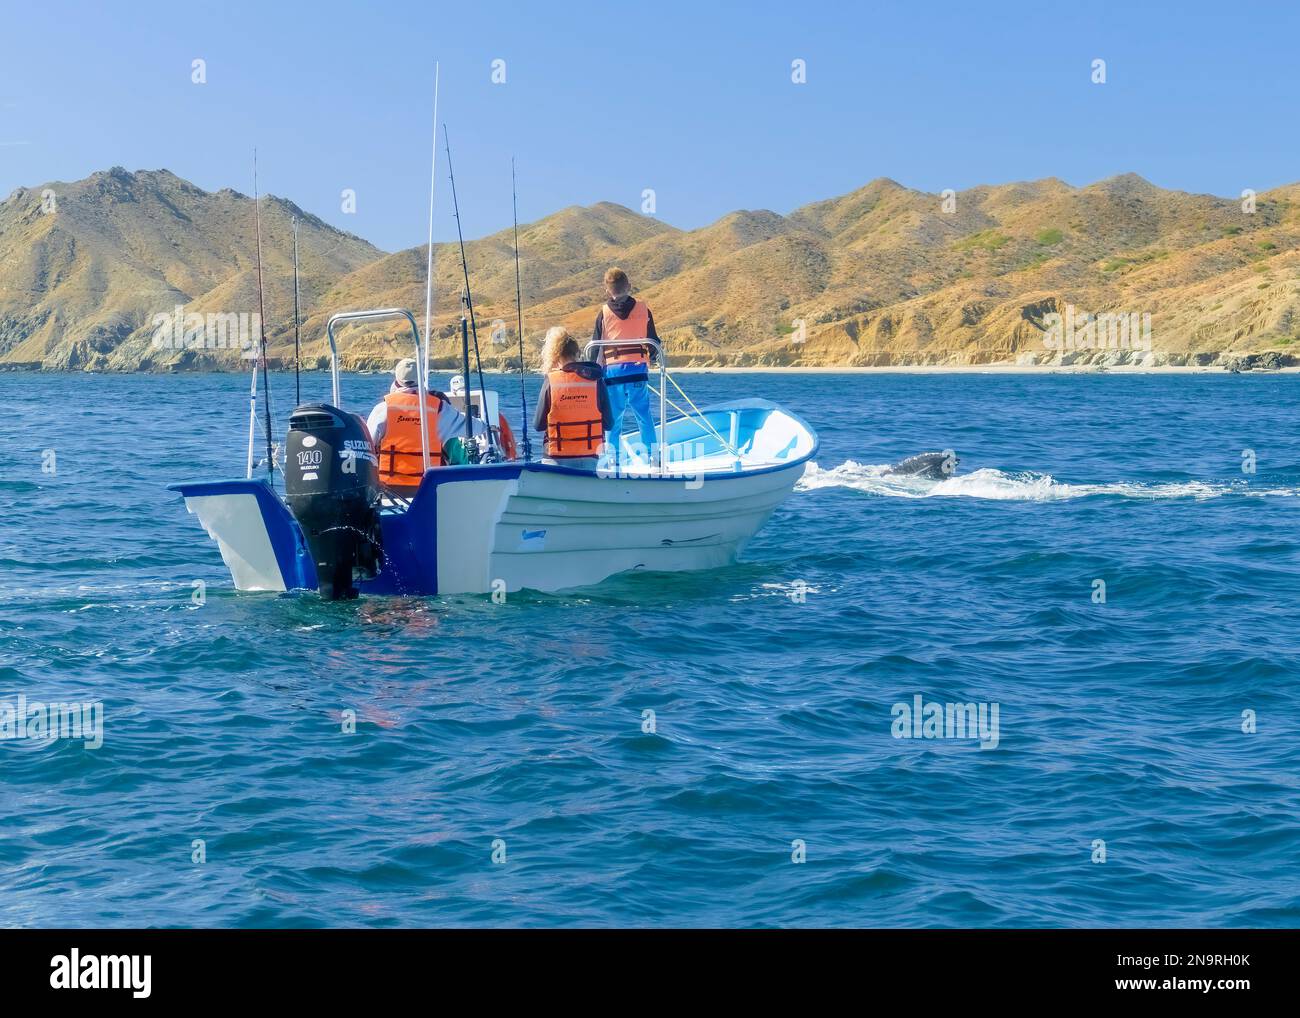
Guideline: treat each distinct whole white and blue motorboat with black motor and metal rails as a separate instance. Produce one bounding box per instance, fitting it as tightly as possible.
[170,308,818,599]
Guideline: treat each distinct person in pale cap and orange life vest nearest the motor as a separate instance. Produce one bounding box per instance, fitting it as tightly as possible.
[367,358,484,489]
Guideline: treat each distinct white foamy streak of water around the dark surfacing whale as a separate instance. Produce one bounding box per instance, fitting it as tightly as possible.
[794,459,1300,502]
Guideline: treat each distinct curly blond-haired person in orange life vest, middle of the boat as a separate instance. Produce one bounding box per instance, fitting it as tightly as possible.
[533,325,614,471]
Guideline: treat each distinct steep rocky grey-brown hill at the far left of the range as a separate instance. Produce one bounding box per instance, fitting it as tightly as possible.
[0,168,381,369]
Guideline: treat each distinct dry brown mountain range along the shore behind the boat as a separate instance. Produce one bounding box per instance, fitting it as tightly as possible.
[0,168,1300,371]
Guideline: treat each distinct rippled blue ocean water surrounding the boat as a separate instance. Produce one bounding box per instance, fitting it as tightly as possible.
[0,374,1300,927]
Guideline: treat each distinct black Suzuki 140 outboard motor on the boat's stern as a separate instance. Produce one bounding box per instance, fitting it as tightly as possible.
[285,403,384,601]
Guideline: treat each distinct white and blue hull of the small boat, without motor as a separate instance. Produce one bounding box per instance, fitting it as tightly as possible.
[173,400,816,594]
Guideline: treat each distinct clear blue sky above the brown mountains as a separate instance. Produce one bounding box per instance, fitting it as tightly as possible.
[0,0,1300,250]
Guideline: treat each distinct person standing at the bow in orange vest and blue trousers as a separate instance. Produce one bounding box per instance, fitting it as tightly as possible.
[592,268,659,459]
